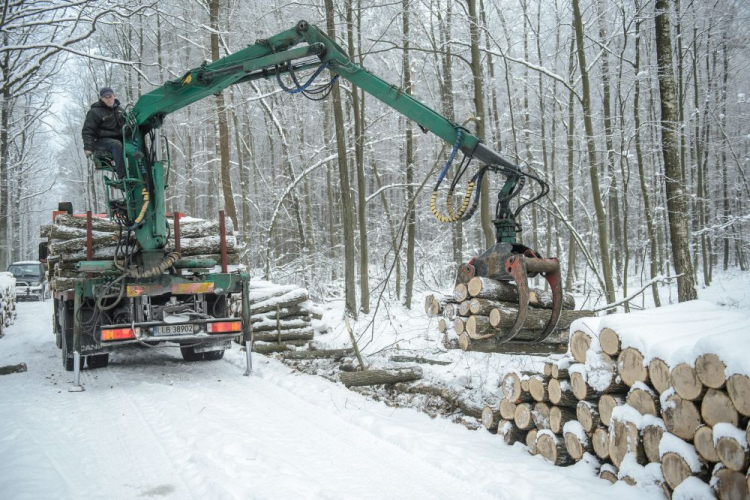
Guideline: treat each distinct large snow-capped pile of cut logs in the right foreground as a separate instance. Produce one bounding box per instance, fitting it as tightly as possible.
[498,301,750,499]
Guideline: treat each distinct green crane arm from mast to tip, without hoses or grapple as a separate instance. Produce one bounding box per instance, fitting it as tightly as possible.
[124,21,528,256]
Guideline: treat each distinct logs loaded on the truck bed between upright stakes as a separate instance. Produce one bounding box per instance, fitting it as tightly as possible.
[39,214,240,290]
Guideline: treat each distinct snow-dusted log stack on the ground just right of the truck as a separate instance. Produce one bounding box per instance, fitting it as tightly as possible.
[242,280,322,353]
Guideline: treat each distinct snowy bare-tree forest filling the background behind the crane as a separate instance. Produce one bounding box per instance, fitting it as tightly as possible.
[0,0,750,311]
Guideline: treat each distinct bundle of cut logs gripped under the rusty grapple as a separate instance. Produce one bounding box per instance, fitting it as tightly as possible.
[425,276,594,354]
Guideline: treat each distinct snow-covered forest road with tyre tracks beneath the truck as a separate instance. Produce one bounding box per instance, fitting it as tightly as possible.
[0,301,658,500]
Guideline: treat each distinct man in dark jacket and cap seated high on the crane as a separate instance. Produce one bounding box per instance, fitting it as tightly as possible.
[81,87,125,179]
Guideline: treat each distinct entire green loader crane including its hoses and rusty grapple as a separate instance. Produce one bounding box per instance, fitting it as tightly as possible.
[107,21,562,340]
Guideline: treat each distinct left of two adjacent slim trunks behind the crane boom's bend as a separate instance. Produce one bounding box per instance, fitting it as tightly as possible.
[325,0,358,318]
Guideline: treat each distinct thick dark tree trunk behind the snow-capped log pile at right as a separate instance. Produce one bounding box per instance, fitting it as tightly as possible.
[655,0,698,302]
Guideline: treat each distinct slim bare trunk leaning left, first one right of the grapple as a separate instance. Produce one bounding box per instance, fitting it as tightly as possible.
[573,0,615,304]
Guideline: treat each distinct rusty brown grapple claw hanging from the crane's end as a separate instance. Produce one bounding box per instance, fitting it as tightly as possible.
[458,243,563,342]
